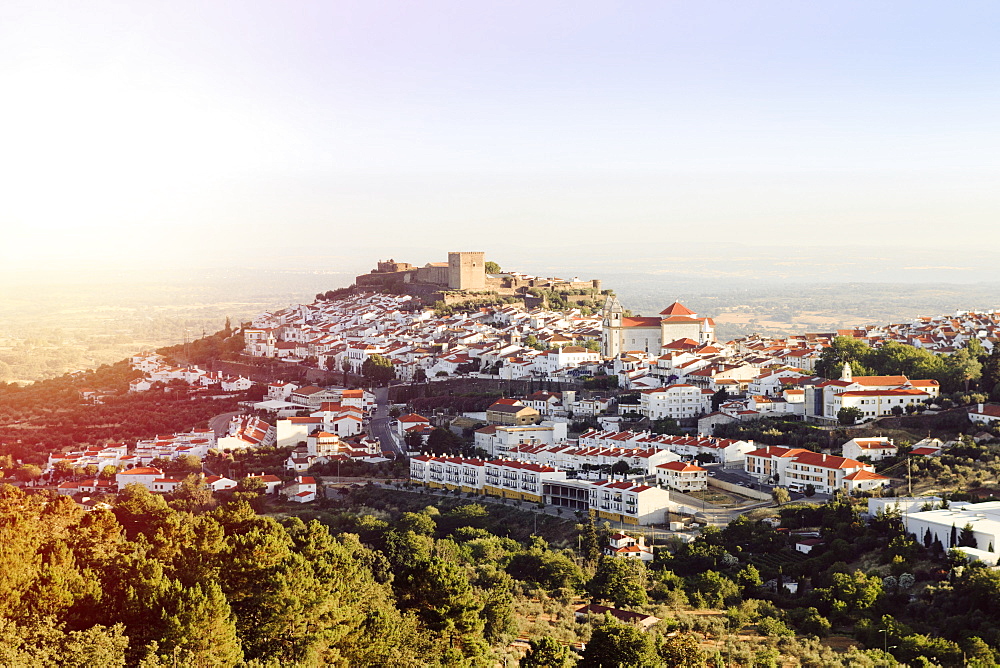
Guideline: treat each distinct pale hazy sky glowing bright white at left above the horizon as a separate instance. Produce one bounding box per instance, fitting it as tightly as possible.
[0,0,1000,276]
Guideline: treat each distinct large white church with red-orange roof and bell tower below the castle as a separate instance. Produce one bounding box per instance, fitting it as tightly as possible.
[601,295,715,357]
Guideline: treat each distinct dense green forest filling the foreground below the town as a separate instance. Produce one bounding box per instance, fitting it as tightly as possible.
[0,468,1000,668]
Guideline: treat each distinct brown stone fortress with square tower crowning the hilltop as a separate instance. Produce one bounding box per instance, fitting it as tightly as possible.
[354,251,601,304]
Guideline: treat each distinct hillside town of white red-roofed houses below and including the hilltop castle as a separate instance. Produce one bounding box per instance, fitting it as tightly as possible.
[8,253,1000,665]
